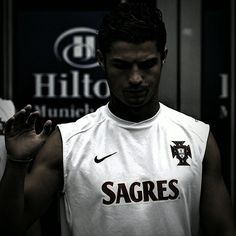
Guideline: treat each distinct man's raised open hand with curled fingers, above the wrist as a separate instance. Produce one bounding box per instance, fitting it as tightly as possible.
[5,105,52,160]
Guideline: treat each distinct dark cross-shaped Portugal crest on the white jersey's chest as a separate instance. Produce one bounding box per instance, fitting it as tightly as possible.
[170,141,192,166]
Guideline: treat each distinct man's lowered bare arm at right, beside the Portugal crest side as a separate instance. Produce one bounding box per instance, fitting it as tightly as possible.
[200,134,236,236]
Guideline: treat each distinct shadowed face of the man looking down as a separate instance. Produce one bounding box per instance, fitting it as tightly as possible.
[103,41,162,107]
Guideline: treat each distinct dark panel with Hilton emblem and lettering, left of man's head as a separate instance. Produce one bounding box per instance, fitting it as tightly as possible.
[13,10,109,128]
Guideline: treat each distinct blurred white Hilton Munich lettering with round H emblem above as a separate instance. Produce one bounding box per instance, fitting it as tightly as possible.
[32,27,110,119]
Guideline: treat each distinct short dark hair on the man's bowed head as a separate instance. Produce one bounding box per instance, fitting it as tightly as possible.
[98,1,166,55]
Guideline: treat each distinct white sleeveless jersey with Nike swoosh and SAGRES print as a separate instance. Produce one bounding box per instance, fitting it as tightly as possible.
[59,104,209,236]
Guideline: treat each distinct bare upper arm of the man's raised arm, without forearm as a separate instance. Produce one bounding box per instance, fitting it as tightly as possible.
[24,130,63,230]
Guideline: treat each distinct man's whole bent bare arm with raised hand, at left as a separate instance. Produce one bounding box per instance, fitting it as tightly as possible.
[0,106,62,235]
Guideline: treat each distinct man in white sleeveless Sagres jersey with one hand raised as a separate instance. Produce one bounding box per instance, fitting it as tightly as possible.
[0,3,235,236]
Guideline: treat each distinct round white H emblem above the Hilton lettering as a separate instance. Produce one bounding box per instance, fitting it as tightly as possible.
[54,27,98,69]
